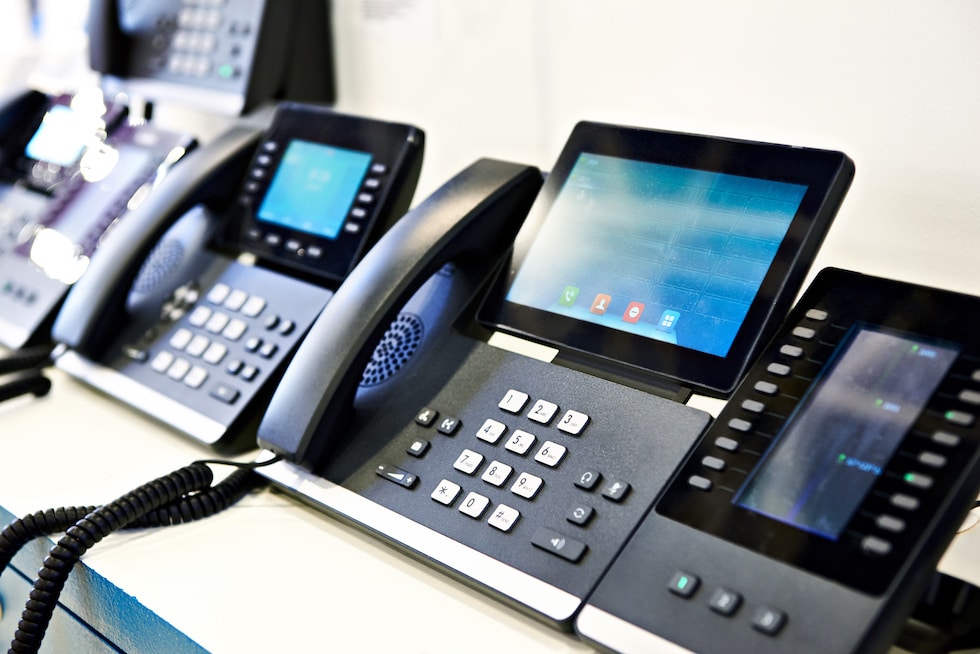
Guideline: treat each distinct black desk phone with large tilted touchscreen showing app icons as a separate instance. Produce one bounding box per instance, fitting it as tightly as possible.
[258,123,853,629]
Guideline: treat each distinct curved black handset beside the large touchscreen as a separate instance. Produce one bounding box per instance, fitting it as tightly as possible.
[258,159,542,465]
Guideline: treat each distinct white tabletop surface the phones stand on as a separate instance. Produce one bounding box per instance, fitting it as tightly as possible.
[0,371,980,654]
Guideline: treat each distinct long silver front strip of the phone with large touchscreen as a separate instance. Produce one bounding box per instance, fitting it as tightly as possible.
[257,456,582,623]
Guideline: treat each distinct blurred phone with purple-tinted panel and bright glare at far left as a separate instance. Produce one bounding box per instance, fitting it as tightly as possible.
[0,89,194,348]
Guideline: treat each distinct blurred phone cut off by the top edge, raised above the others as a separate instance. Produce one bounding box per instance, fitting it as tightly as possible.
[89,0,335,115]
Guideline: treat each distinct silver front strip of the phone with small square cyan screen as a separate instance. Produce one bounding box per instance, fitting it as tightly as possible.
[55,350,227,445]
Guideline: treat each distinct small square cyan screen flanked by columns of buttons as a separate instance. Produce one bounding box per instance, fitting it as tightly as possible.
[256,140,371,239]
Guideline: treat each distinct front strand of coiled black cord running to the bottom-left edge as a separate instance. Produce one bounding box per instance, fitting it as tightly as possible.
[8,464,214,654]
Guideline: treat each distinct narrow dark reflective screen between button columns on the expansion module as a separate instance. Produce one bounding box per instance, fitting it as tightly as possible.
[733,326,959,540]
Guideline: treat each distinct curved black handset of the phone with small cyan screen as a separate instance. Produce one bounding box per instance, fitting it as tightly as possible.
[51,123,262,357]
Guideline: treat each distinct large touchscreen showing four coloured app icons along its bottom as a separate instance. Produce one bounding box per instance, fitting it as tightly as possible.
[506,152,807,357]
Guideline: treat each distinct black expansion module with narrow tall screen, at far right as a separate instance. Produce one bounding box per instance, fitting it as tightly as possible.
[577,269,980,654]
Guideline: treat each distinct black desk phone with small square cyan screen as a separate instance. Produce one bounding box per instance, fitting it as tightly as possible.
[52,103,424,447]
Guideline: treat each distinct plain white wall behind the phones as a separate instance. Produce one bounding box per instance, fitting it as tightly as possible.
[0,0,980,294]
